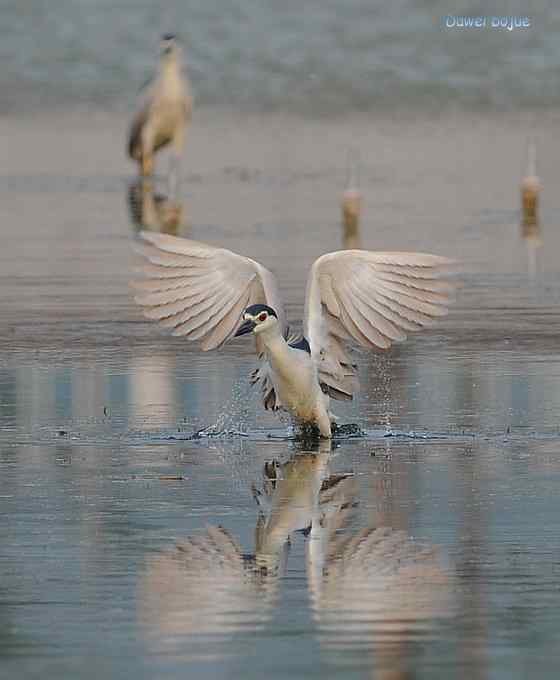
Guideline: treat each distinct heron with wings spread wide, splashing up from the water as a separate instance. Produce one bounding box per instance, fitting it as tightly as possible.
[135,232,453,437]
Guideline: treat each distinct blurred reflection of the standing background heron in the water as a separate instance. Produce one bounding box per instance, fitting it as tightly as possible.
[127,179,191,237]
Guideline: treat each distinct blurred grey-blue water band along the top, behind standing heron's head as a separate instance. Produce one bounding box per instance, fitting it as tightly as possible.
[0,0,560,118]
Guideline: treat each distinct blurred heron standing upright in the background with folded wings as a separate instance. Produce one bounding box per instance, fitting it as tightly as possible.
[128,35,192,176]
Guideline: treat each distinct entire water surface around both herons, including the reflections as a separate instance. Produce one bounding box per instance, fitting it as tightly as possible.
[0,5,560,680]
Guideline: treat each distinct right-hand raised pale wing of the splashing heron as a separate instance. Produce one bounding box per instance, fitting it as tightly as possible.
[304,250,454,399]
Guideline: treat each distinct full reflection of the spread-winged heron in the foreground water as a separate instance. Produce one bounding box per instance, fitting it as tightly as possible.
[139,442,449,651]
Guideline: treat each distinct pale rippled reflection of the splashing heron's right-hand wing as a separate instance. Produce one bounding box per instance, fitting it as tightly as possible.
[311,527,447,646]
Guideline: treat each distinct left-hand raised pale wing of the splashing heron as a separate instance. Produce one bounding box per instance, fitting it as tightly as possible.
[133,231,286,351]
